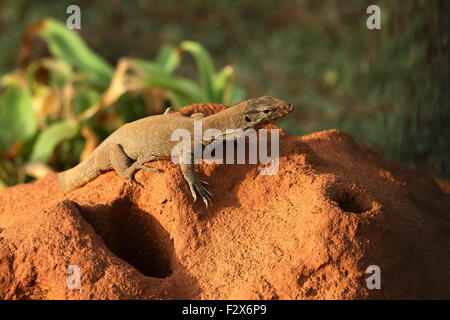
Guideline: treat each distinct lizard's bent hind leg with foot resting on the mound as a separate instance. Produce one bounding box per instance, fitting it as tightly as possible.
[96,144,160,186]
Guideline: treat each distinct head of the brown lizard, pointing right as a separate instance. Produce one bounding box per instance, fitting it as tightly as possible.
[237,96,294,129]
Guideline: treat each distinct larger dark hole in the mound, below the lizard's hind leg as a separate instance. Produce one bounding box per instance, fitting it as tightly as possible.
[81,199,174,278]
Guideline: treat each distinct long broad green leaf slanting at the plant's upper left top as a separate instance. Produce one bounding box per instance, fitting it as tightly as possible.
[37,18,114,86]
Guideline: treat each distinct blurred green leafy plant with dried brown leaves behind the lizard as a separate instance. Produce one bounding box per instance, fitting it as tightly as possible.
[0,19,244,188]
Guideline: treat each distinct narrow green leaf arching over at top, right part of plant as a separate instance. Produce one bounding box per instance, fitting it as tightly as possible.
[180,41,215,102]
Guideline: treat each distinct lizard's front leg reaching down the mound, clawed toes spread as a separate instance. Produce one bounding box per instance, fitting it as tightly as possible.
[180,152,212,208]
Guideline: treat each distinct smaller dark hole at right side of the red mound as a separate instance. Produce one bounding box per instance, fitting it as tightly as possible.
[330,185,373,213]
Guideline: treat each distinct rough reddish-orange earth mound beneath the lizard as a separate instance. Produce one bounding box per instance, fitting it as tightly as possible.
[0,105,450,299]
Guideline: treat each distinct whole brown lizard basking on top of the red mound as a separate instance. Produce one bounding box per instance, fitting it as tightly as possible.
[58,96,294,207]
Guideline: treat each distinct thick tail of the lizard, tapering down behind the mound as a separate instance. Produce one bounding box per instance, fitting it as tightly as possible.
[58,156,102,192]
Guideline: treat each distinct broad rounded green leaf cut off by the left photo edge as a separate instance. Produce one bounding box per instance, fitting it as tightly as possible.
[0,85,37,150]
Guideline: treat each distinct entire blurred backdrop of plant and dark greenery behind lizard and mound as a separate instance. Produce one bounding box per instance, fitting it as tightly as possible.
[0,0,450,188]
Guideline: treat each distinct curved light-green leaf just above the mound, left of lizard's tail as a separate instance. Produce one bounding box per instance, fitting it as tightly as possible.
[30,120,78,162]
